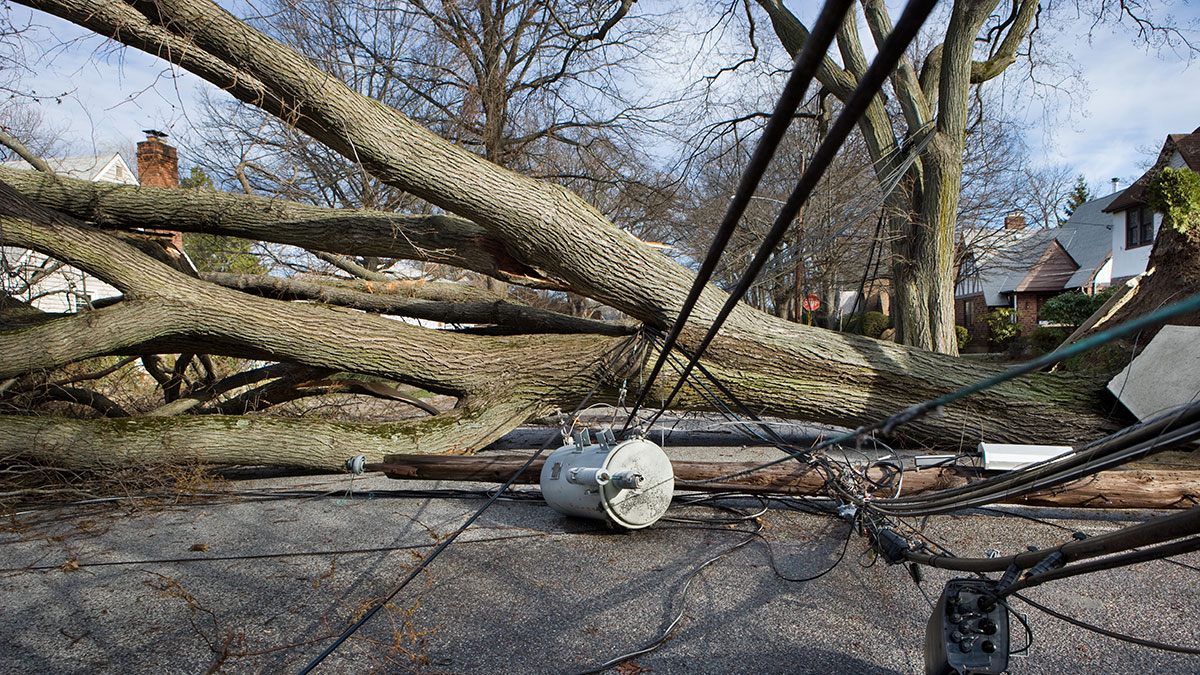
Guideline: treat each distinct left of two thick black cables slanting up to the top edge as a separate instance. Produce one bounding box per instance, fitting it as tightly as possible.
[622,0,854,432]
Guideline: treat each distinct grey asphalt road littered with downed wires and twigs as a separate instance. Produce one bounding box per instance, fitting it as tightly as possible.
[0,427,1200,675]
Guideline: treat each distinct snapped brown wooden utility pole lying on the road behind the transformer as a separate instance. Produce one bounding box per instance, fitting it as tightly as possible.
[365,455,1200,509]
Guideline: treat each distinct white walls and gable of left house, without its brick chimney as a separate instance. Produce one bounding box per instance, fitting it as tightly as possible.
[0,153,138,312]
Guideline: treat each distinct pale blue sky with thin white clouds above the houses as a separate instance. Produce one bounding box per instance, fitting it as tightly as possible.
[8,2,1200,195]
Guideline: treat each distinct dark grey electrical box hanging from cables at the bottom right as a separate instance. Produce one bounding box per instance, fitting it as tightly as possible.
[925,571,1008,675]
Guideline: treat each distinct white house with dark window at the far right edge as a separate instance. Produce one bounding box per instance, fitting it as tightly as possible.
[1104,127,1200,281]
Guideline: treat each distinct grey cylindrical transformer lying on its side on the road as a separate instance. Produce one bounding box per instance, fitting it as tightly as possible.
[541,431,674,530]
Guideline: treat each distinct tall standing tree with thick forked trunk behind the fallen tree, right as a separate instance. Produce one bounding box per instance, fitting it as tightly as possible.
[758,0,1190,353]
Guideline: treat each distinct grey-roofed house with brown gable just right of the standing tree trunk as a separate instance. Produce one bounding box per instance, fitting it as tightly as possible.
[954,192,1118,345]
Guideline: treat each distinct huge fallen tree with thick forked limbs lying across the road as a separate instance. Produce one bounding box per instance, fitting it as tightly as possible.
[0,0,1111,466]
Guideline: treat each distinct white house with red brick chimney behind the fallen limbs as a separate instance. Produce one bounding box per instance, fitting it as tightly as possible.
[0,132,182,313]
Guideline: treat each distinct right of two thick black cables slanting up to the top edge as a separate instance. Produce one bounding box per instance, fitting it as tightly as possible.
[652,0,937,424]
